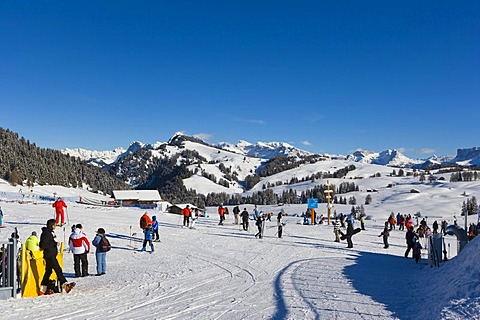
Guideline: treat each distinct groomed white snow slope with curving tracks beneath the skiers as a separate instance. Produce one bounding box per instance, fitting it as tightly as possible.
[0,179,480,320]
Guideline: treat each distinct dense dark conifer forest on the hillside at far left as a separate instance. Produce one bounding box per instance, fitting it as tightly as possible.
[0,128,130,194]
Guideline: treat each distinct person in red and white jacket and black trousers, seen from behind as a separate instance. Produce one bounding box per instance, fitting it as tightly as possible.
[68,223,90,278]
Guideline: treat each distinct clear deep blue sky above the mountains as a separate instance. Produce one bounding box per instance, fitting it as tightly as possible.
[0,0,480,158]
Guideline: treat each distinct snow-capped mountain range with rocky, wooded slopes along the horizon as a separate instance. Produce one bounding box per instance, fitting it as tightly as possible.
[62,132,480,194]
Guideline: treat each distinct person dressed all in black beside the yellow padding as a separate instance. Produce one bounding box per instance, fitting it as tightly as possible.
[39,219,75,295]
